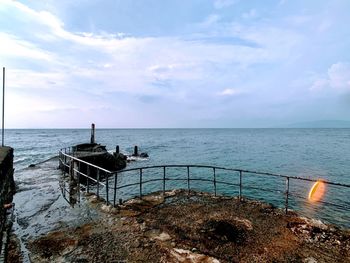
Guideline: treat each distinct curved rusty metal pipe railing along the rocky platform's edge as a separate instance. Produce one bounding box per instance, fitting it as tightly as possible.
[59,149,350,227]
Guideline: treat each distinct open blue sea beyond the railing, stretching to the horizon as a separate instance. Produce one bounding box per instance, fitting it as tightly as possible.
[5,129,350,232]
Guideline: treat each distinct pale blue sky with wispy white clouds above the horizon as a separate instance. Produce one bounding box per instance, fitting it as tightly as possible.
[0,0,350,128]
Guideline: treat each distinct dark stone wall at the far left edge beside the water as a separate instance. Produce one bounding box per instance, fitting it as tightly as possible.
[0,147,15,262]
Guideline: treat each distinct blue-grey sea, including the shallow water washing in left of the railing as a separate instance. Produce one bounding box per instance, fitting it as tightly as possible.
[5,128,350,260]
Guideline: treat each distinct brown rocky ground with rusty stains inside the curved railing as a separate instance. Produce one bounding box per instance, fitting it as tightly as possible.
[10,190,350,263]
